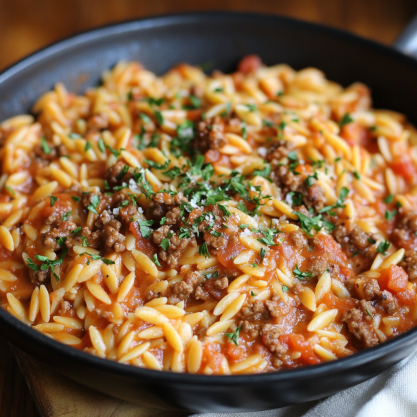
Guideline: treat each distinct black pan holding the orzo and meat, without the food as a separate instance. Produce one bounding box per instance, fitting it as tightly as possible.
[0,13,417,412]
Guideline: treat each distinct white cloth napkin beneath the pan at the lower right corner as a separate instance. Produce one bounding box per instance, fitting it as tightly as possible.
[192,353,417,417]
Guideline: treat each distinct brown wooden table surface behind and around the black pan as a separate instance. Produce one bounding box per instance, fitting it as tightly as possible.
[0,0,417,417]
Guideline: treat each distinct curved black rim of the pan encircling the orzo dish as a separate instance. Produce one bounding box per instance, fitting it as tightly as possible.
[0,11,417,386]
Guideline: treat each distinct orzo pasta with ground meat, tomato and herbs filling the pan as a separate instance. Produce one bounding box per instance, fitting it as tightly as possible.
[0,56,417,374]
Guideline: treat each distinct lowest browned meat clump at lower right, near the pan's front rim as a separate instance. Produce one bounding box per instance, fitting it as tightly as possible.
[342,300,379,347]
